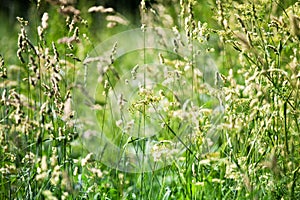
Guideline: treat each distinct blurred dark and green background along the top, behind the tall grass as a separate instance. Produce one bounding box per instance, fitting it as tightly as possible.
[0,0,297,64]
